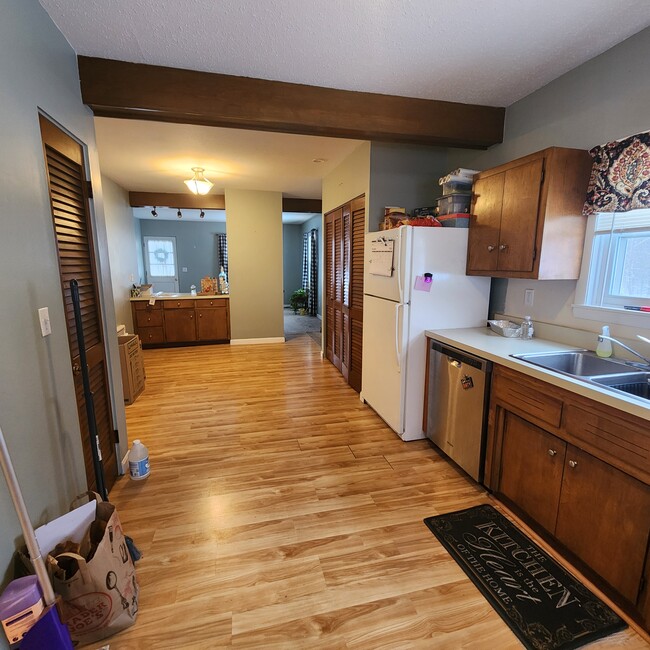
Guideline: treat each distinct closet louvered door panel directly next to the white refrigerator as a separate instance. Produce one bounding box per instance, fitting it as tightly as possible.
[348,196,366,392]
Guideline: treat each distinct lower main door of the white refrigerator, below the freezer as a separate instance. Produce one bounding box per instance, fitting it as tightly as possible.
[361,296,409,435]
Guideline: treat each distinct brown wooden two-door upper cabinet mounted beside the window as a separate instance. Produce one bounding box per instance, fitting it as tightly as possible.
[467,147,591,280]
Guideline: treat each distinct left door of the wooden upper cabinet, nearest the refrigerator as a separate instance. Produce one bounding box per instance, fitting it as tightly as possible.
[467,173,505,271]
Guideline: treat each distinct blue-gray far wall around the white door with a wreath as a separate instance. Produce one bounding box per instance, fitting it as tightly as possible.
[136,219,225,293]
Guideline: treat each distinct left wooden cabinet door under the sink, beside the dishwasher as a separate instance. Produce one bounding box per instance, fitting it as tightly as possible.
[498,411,567,533]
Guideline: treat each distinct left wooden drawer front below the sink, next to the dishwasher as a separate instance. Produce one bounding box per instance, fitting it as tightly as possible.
[492,368,562,427]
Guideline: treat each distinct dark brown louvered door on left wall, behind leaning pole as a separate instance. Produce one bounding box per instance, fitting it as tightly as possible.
[40,116,118,490]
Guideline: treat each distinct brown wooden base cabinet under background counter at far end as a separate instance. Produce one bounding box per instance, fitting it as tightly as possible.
[131,298,230,347]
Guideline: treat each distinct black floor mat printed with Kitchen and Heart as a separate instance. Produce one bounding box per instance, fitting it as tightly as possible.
[424,505,627,650]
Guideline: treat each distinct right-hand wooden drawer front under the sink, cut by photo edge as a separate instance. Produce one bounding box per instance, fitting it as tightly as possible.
[565,404,650,484]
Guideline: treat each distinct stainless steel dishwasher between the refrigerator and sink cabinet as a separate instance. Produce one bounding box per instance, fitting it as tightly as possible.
[426,341,492,483]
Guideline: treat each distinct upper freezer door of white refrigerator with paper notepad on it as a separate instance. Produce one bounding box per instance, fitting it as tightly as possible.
[363,226,413,302]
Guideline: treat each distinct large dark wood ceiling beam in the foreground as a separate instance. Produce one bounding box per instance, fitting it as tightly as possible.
[78,56,505,149]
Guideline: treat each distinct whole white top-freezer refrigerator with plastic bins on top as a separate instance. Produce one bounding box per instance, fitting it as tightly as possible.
[361,226,491,440]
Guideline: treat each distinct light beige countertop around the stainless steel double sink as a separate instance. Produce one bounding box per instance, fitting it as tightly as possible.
[425,327,650,421]
